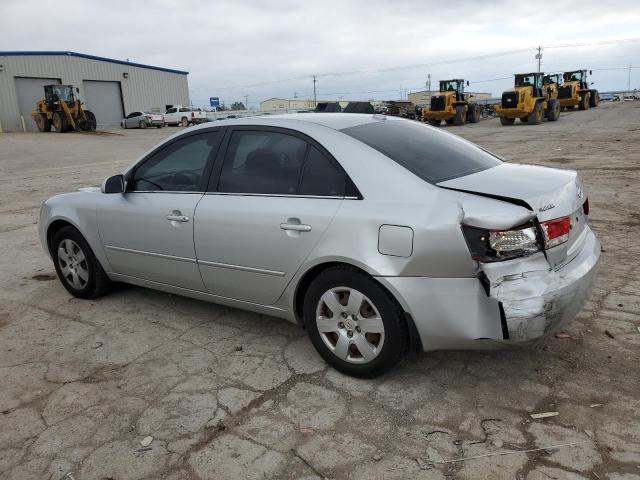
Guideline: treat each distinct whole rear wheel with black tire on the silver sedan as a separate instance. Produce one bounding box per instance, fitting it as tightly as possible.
[303,266,409,378]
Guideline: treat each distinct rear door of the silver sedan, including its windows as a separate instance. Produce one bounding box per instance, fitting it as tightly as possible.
[194,127,347,305]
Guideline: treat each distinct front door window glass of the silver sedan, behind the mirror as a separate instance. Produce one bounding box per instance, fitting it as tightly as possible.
[128,130,222,192]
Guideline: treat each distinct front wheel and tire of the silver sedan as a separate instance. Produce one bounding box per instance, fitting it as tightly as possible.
[51,225,111,298]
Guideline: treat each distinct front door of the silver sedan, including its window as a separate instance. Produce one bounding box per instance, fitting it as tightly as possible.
[97,129,223,291]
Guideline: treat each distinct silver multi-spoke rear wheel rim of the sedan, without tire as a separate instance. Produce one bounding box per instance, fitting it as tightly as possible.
[316,287,385,364]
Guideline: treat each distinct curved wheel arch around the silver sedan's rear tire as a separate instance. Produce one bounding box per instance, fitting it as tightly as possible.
[293,260,423,354]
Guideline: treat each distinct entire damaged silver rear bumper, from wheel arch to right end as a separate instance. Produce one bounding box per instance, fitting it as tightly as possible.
[376,227,600,351]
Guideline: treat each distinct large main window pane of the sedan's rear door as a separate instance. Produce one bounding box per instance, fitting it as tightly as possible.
[218,131,307,195]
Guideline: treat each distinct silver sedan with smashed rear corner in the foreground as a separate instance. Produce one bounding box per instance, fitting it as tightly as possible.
[39,113,600,377]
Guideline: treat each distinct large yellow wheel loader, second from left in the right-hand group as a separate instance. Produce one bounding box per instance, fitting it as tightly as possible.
[496,72,560,125]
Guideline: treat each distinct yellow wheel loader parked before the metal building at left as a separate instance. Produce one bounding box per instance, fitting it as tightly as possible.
[31,85,96,133]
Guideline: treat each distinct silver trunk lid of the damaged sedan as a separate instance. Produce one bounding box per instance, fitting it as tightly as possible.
[438,163,587,268]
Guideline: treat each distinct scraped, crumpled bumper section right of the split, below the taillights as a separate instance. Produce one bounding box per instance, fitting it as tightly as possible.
[482,227,600,342]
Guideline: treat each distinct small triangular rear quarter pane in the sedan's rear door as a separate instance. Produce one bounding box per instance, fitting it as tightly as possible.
[300,147,345,197]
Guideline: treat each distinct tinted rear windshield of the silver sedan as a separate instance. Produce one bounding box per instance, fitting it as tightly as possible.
[340,120,502,184]
